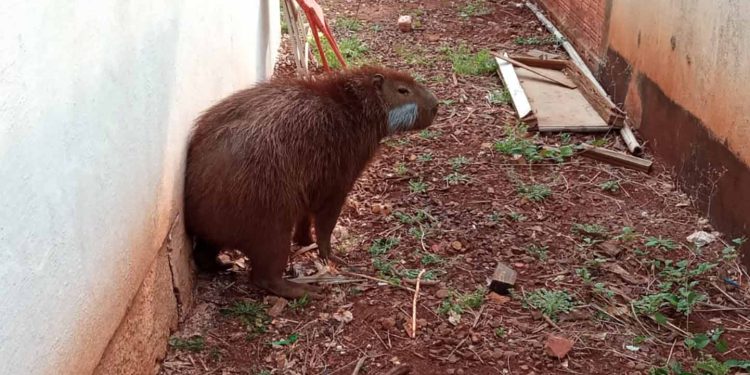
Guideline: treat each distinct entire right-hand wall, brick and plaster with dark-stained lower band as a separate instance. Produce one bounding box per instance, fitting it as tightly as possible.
[542,0,750,265]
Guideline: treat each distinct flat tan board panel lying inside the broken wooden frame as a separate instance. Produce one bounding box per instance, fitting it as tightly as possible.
[515,67,611,132]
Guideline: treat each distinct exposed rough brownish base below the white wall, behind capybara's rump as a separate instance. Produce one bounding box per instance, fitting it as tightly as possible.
[94,217,195,375]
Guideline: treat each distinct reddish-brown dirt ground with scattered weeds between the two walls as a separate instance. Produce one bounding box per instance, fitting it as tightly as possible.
[161,0,750,375]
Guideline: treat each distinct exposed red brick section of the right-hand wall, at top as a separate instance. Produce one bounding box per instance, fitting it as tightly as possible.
[539,0,609,73]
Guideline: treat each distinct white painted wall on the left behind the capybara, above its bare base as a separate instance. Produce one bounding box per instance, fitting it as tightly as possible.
[0,0,279,375]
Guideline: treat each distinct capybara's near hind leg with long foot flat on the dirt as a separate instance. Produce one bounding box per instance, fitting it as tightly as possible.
[247,231,321,299]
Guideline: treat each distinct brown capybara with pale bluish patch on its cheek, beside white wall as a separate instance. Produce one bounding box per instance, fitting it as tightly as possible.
[185,67,438,298]
